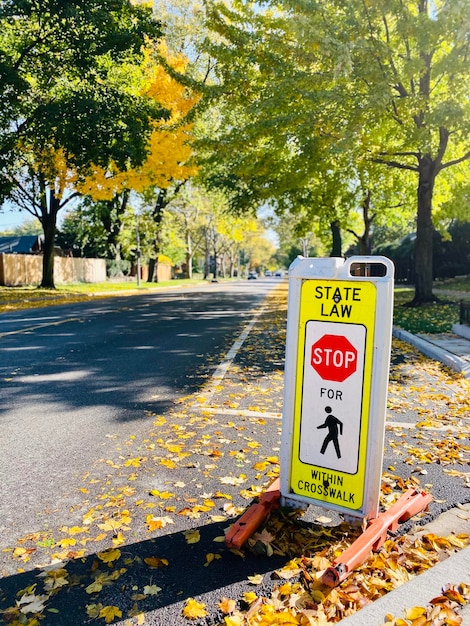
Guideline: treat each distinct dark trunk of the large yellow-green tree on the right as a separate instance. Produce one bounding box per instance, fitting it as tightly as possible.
[413,156,436,304]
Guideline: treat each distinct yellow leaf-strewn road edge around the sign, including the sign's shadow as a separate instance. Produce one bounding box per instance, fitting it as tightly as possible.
[0,286,470,626]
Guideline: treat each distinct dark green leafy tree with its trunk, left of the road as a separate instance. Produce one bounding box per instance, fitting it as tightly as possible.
[0,0,166,287]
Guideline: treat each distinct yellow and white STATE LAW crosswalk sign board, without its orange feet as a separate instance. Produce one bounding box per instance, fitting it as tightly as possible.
[281,257,393,517]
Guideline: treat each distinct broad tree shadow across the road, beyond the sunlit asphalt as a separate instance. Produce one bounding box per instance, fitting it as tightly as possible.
[0,292,283,422]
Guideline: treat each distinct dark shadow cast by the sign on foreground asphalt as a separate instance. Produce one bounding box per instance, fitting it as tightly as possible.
[0,523,286,626]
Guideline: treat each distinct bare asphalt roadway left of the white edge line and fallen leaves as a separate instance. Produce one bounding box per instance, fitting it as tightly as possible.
[0,280,275,546]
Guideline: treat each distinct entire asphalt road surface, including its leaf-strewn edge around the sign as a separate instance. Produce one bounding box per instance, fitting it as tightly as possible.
[0,279,469,626]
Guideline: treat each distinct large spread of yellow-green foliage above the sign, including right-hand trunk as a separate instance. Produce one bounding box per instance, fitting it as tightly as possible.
[198,0,470,303]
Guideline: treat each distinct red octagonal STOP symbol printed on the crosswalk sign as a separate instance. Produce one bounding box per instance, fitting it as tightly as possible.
[311,335,357,383]
